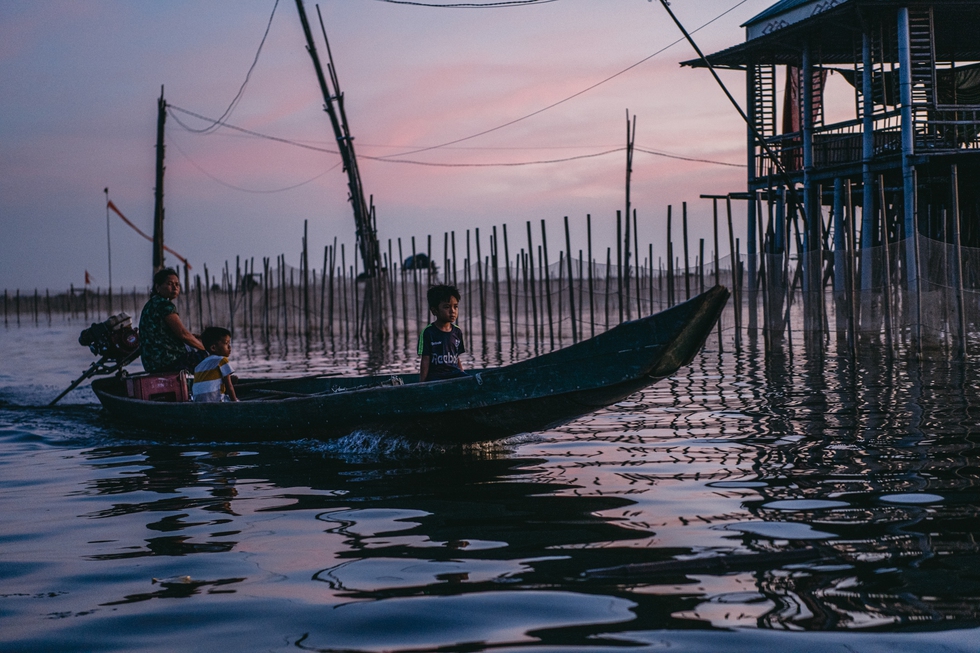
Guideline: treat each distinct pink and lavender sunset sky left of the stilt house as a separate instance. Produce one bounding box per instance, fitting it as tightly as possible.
[0,0,772,291]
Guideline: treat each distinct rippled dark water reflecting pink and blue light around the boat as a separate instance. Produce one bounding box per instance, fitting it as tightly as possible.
[0,326,980,653]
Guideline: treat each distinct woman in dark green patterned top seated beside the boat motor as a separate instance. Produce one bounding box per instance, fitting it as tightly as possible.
[139,268,207,373]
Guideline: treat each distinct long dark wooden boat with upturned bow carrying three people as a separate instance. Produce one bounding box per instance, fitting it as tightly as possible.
[92,286,729,443]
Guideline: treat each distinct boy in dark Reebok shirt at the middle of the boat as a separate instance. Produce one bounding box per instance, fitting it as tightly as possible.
[419,284,466,381]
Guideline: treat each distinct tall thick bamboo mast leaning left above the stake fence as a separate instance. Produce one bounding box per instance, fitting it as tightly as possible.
[296,0,381,277]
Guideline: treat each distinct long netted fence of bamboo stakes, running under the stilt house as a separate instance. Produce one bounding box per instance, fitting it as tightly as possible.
[9,188,980,360]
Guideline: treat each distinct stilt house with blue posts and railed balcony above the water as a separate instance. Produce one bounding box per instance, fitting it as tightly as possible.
[684,0,980,342]
